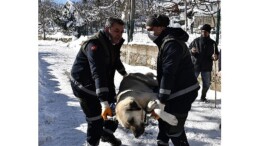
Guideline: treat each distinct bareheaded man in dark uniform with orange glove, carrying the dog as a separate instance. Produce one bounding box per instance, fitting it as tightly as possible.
[70,17,127,146]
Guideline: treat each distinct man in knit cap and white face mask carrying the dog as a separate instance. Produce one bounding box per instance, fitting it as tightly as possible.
[146,14,200,146]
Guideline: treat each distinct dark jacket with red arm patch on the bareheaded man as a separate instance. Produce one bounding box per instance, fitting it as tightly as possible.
[71,31,126,101]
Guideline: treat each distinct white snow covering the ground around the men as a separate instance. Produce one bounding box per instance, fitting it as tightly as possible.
[38,31,221,146]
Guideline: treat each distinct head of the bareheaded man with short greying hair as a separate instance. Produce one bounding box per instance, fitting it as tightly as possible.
[105,17,124,44]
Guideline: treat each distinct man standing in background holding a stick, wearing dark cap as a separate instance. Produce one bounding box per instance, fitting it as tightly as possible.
[189,24,219,102]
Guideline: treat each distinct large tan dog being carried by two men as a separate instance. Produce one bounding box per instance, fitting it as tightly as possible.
[115,73,178,138]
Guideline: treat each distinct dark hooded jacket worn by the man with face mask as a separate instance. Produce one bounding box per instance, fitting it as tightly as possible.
[154,27,199,103]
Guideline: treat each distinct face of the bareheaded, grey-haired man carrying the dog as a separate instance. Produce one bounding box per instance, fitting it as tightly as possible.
[108,23,124,44]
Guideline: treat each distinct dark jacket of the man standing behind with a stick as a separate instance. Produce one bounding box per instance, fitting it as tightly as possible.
[189,37,219,72]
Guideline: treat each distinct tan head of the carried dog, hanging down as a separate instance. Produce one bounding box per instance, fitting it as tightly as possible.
[116,98,145,138]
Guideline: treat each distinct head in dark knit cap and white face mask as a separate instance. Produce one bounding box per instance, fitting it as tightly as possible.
[146,14,170,40]
